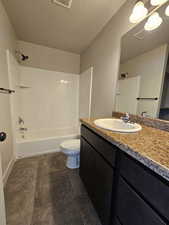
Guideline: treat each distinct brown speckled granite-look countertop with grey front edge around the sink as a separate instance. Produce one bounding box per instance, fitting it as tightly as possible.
[80,119,169,181]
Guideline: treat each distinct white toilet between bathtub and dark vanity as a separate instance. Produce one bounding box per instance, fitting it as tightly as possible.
[60,139,80,169]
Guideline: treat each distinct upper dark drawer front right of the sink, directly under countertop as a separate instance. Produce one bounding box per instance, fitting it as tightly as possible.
[120,153,169,220]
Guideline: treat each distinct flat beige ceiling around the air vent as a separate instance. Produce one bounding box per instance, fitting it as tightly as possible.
[3,0,126,53]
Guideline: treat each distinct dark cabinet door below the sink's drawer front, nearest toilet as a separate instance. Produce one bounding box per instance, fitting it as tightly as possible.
[80,138,113,225]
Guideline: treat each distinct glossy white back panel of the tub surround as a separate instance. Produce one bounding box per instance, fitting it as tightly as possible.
[20,66,79,132]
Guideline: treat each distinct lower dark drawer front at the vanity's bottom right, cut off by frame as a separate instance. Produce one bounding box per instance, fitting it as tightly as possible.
[117,178,166,225]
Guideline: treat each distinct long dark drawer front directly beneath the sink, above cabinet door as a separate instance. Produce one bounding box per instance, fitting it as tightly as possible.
[81,125,117,166]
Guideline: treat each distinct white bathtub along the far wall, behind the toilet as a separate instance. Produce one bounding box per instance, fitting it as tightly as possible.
[16,128,80,158]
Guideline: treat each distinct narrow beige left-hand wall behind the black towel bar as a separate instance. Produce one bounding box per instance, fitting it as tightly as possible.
[0,1,16,179]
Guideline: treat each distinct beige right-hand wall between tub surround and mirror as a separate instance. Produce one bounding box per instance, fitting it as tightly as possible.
[81,0,135,117]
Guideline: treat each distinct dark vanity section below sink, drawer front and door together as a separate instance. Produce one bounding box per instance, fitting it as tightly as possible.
[80,127,115,225]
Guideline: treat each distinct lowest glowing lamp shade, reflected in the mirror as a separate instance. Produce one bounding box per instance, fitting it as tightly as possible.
[144,12,163,31]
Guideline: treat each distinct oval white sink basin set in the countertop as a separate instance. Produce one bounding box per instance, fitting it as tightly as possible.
[94,119,142,133]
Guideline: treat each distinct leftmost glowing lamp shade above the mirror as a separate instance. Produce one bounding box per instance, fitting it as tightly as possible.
[130,1,148,23]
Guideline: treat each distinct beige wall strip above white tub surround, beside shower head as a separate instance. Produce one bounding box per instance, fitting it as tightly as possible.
[17,41,80,74]
